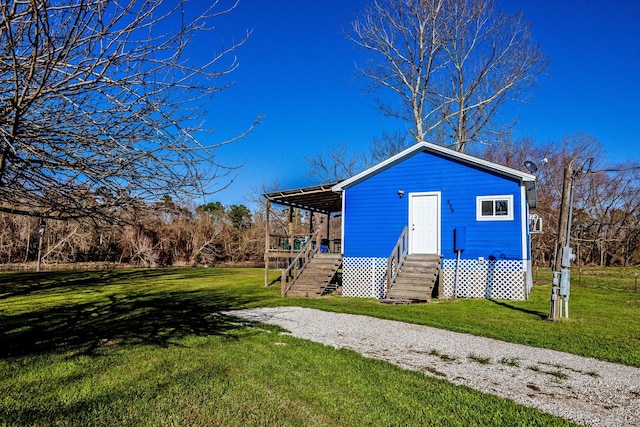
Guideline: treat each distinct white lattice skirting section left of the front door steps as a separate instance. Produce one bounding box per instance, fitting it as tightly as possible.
[342,257,387,299]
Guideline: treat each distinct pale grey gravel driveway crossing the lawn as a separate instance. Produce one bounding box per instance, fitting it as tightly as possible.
[226,307,640,427]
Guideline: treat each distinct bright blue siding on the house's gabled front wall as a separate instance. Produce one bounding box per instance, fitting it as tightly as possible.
[343,152,526,259]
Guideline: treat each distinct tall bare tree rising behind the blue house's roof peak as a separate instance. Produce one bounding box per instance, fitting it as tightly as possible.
[348,0,548,151]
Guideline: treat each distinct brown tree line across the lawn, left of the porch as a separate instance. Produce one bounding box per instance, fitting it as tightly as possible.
[0,198,264,267]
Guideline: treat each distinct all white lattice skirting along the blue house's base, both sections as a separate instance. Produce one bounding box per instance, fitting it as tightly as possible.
[342,257,531,300]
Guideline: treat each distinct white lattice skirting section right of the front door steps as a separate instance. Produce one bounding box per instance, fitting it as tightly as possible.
[442,259,528,300]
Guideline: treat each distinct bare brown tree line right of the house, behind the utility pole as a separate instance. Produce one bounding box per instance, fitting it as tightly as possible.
[484,133,640,267]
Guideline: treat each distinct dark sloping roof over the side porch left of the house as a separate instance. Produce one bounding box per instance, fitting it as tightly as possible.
[264,182,342,214]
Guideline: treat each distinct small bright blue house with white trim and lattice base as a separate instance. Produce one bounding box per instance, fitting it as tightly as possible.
[264,142,535,300]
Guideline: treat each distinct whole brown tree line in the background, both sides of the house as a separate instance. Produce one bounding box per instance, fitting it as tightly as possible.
[0,134,640,267]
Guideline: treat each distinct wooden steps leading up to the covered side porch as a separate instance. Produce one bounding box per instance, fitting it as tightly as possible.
[286,253,342,298]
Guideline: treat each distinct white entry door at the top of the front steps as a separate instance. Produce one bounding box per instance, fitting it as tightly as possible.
[409,193,440,254]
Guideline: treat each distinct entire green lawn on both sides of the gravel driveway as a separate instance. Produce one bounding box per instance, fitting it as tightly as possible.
[0,269,640,426]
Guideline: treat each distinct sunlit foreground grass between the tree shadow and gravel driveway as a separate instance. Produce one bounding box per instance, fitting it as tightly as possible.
[0,328,570,426]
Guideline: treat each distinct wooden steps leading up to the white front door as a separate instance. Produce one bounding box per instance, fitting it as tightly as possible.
[384,254,441,303]
